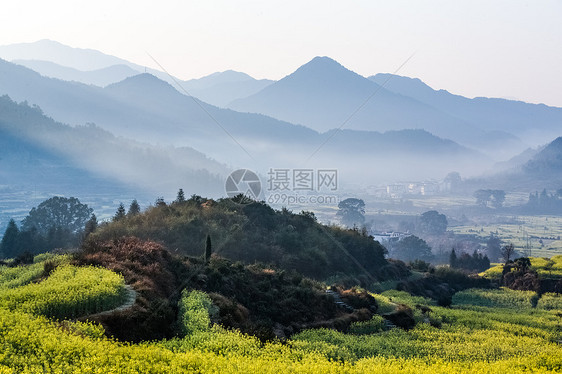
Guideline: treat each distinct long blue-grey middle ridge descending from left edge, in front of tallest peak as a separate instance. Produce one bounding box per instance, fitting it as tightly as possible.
[0,61,488,184]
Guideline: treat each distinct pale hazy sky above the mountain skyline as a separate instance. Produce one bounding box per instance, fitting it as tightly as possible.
[0,0,562,107]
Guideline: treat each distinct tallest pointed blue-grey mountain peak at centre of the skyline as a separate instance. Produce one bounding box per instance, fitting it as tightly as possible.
[229,57,484,145]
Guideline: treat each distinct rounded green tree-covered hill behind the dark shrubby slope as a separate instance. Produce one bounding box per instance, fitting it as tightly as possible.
[91,193,400,285]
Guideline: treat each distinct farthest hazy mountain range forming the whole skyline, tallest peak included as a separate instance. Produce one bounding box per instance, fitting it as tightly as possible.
[0,40,562,161]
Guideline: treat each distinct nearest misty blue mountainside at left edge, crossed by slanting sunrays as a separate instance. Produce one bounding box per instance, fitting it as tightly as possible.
[0,96,228,234]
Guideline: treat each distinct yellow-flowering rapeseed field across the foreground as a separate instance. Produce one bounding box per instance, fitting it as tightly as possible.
[0,258,562,374]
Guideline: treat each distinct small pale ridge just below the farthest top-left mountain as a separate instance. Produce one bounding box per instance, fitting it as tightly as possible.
[12,60,140,87]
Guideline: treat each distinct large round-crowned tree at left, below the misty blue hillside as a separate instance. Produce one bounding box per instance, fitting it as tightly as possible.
[22,196,93,235]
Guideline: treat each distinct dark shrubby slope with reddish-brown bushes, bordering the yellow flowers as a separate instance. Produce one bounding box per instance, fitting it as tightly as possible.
[75,238,377,342]
